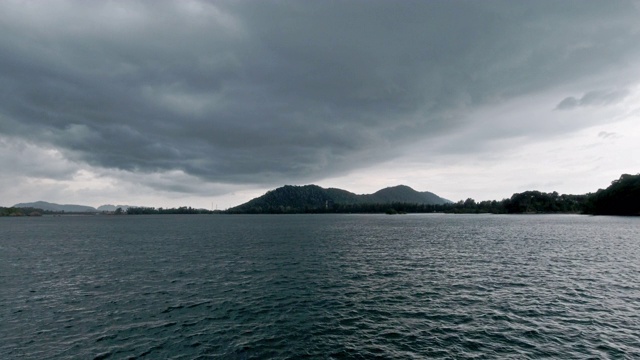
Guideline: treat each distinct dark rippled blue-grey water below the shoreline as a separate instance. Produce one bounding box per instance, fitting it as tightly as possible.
[0,215,640,359]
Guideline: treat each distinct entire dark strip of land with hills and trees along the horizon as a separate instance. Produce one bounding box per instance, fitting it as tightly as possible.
[0,174,640,216]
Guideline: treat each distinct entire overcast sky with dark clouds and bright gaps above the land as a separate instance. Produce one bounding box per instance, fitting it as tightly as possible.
[0,0,640,208]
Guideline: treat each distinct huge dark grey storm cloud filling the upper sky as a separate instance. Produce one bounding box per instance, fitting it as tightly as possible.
[0,1,640,189]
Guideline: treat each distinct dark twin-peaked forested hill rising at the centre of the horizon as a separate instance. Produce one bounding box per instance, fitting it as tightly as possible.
[227,185,450,213]
